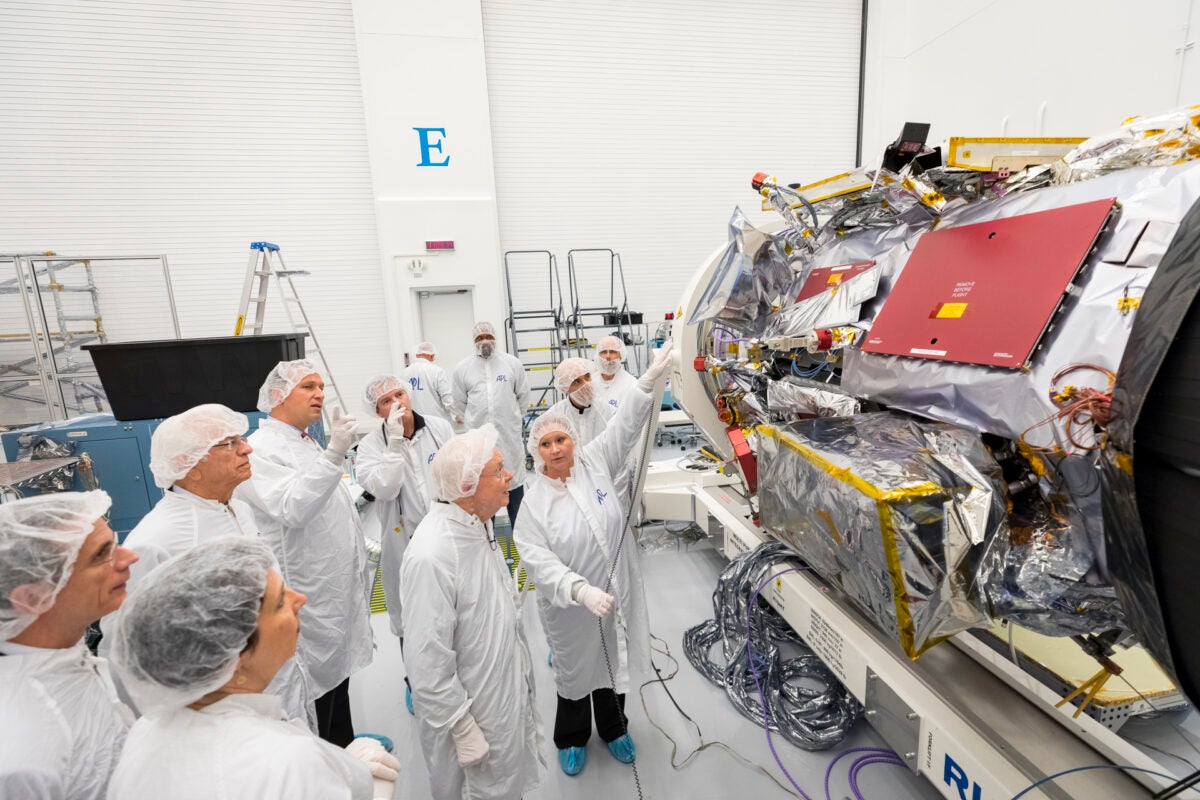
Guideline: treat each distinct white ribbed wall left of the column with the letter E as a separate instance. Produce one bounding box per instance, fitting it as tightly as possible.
[0,0,390,412]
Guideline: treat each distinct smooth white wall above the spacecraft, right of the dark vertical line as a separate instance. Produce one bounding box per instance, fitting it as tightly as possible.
[863,0,1200,166]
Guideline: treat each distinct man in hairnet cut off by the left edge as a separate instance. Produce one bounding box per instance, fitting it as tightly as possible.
[0,492,138,800]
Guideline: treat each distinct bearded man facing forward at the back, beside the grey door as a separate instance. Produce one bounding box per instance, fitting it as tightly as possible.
[450,323,529,523]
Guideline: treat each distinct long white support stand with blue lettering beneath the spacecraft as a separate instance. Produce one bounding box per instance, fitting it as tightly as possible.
[643,465,1200,800]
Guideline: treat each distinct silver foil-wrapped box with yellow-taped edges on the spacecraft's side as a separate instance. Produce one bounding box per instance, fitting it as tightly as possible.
[758,411,1006,658]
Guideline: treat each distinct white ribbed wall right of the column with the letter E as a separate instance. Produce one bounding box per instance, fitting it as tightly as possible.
[481,0,862,342]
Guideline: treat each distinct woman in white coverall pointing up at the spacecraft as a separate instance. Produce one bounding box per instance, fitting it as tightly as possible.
[512,344,671,775]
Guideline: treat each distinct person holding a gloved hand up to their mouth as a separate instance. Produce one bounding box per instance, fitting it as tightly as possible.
[355,375,454,712]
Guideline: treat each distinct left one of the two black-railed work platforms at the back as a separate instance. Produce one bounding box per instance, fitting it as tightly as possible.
[504,249,570,415]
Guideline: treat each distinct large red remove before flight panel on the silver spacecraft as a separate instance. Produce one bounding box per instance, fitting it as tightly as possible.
[863,198,1115,368]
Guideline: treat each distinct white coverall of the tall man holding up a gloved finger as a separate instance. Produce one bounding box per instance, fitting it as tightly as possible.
[236,416,374,700]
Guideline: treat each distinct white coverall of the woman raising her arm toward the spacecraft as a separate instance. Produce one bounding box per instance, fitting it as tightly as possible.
[512,386,650,700]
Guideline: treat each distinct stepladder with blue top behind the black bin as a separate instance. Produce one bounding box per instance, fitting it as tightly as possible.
[233,241,352,419]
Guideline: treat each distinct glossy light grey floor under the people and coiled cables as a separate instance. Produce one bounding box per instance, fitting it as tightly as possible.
[350,525,940,800]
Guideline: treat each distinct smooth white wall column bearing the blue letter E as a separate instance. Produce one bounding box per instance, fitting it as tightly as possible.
[353,0,504,369]
